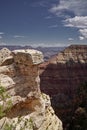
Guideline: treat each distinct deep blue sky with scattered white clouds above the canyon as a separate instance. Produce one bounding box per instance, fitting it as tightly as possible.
[0,0,87,46]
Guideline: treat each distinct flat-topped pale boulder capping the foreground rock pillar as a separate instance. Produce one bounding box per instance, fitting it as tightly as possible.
[12,49,43,66]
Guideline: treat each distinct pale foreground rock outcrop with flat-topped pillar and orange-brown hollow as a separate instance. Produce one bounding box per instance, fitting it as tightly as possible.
[0,49,62,130]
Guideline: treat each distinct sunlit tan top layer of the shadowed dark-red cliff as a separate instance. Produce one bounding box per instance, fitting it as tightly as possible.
[57,45,87,63]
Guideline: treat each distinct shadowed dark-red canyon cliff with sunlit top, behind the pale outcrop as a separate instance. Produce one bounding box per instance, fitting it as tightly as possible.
[40,45,87,128]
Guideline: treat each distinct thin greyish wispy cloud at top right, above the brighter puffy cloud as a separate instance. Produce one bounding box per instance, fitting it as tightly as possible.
[50,0,87,16]
